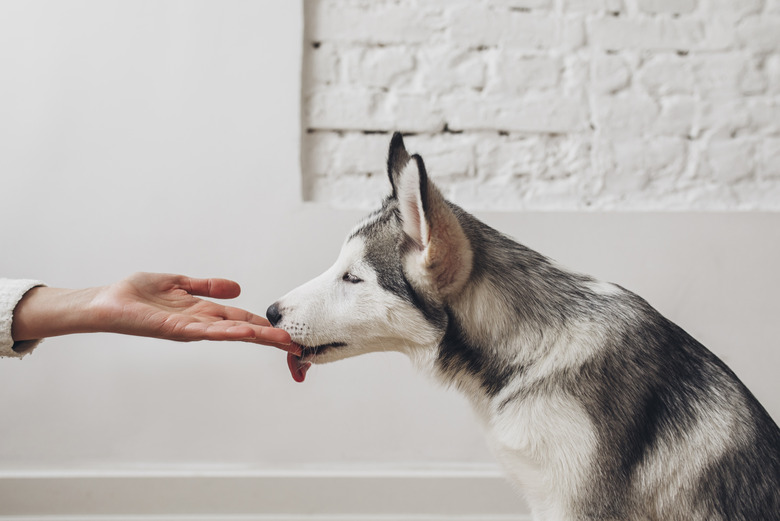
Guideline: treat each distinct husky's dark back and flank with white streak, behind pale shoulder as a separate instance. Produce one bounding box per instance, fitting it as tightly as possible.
[556,293,780,521]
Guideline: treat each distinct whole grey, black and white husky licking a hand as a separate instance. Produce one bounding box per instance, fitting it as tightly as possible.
[267,133,780,521]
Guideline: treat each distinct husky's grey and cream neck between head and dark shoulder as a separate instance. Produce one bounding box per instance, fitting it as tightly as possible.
[426,213,594,409]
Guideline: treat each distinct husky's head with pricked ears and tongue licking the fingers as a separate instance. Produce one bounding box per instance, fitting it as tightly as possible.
[267,133,472,381]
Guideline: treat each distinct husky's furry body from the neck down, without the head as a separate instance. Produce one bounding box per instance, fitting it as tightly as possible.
[438,208,780,521]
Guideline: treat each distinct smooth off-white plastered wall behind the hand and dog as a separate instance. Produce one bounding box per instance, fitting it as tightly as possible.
[0,1,780,514]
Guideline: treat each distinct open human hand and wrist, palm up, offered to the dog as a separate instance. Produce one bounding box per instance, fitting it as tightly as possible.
[13,273,300,352]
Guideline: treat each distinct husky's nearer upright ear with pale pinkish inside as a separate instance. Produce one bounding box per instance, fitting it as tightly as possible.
[393,150,473,297]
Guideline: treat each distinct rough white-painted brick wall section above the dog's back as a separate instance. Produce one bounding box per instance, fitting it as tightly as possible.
[302,0,780,211]
